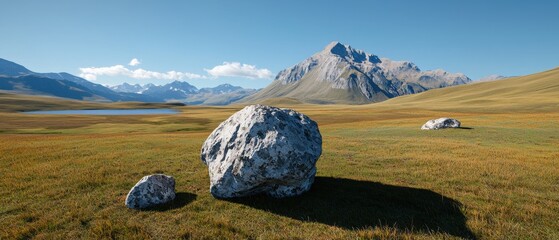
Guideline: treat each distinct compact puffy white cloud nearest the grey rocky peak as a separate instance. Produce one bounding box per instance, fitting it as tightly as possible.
[204,62,273,78]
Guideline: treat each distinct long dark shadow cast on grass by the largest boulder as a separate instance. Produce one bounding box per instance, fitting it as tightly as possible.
[228,177,475,239]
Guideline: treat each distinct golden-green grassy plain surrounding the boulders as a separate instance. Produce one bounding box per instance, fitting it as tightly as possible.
[0,69,559,239]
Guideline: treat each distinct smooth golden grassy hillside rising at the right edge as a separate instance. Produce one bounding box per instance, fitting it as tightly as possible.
[374,68,559,112]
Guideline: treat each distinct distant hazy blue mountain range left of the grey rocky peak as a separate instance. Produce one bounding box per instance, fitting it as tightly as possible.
[0,58,256,105]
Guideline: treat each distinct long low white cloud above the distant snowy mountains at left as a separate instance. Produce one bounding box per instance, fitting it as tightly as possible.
[80,64,206,80]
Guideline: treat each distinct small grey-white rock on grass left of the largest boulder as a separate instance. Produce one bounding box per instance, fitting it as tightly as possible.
[126,174,175,209]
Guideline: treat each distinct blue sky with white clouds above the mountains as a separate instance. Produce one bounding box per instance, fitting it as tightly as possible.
[0,0,559,88]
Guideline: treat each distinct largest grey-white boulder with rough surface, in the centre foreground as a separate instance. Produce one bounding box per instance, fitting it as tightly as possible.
[201,105,322,198]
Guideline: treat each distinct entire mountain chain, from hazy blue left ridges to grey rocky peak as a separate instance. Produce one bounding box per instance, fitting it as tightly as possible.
[0,42,480,105]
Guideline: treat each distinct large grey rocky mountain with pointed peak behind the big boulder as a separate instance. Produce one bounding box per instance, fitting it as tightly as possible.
[240,42,471,104]
